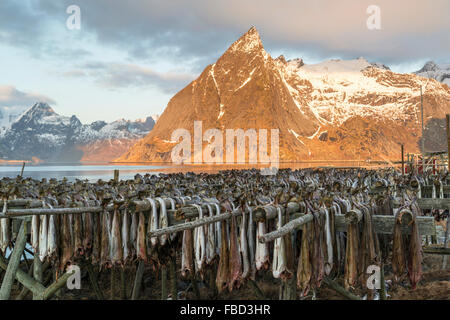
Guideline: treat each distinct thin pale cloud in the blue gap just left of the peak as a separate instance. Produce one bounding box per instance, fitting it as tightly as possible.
[63,62,195,94]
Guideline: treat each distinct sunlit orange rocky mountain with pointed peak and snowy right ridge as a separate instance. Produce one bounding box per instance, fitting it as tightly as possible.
[117,28,450,162]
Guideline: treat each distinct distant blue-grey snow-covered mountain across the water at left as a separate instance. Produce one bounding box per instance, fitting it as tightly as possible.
[0,103,155,161]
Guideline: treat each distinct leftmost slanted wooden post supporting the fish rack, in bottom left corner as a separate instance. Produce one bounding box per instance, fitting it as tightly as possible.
[0,221,26,300]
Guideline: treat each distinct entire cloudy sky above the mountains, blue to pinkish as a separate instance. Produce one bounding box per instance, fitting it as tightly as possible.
[0,0,450,122]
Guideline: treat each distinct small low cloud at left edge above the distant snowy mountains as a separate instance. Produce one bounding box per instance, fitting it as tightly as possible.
[0,85,56,107]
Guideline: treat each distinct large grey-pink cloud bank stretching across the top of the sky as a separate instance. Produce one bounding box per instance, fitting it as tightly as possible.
[0,0,450,67]
